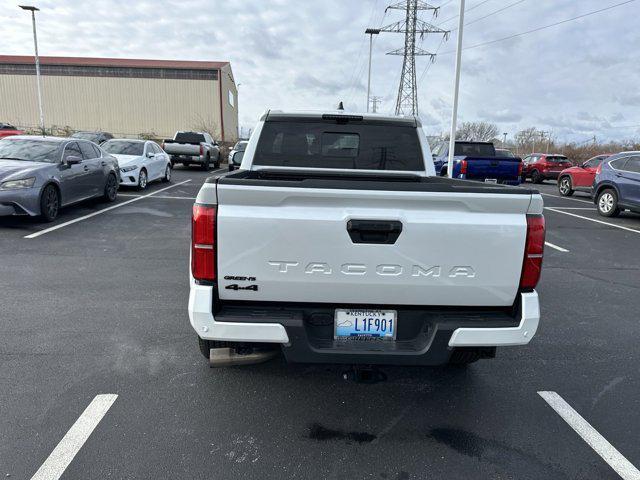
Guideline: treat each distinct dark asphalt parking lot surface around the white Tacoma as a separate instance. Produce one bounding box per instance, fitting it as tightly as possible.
[0,173,640,480]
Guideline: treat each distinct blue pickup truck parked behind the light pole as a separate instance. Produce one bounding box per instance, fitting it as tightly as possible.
[431,141,522,185]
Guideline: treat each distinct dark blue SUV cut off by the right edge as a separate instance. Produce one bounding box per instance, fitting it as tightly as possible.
[593,152,640,217]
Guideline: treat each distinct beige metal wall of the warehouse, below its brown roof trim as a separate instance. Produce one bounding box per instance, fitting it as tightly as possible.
[0,75,230,139]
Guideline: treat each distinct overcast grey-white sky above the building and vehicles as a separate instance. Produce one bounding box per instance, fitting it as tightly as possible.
[0,0,640,142]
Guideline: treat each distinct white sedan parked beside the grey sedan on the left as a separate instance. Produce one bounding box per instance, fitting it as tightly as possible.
[101,139,171,190]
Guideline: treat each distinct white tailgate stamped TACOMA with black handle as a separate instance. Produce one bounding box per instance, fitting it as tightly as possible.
[217,183,531,306]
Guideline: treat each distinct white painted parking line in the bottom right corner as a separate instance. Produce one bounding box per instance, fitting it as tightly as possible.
[538,392,640,480]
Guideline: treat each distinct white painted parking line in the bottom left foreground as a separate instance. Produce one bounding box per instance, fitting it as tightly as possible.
[31,393,118,480]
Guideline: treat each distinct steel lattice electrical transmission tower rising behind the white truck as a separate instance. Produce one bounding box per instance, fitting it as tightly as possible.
[380,0,449,115]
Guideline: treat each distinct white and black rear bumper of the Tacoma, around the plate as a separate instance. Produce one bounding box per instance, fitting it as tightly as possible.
[189,284,540,365]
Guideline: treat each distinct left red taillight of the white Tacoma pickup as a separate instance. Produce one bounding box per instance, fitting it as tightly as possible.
[191,205,216,282]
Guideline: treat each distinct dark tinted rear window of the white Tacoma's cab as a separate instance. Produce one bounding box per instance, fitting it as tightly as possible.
[253,121,424,172]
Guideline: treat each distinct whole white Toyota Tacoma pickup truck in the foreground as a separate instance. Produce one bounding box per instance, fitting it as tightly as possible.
[189,111,545,365]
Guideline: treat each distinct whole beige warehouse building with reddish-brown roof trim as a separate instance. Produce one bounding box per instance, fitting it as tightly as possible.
[0,55,238,142]
